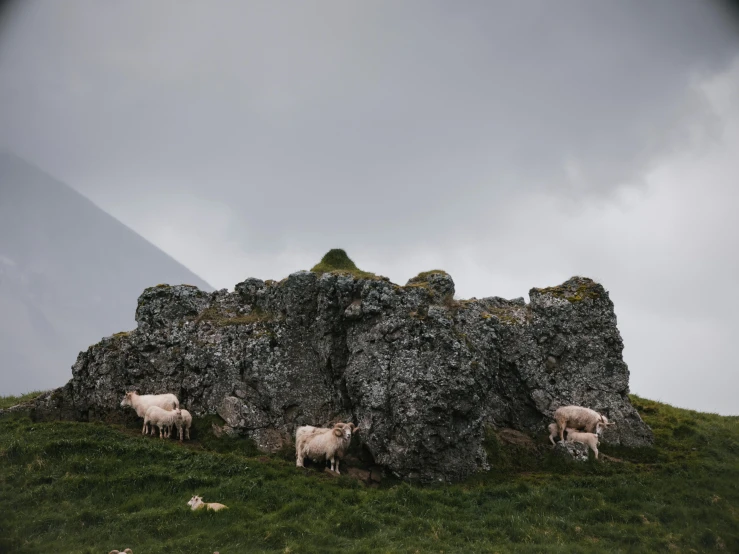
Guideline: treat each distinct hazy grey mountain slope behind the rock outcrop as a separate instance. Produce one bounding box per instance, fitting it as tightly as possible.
[0,152,212,394]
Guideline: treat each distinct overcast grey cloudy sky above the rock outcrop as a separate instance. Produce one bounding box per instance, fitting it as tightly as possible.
[0,0,739,414]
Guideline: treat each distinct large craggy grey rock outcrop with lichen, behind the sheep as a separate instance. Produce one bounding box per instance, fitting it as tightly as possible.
[37,271,652,481]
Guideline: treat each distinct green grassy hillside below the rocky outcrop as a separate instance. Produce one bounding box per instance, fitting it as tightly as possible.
[0,397,739,554]
